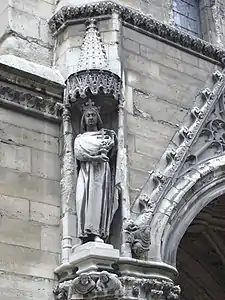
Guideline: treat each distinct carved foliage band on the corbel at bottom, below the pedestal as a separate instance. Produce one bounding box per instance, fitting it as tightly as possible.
[53,271,181,300]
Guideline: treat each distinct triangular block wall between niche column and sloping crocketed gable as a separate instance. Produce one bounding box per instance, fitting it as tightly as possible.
[121,27,221,202]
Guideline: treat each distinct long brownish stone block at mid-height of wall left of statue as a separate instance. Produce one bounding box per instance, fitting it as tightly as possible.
[0,167,60,205]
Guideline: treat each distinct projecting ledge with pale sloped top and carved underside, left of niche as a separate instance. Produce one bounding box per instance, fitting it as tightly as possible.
[0,55,65,122]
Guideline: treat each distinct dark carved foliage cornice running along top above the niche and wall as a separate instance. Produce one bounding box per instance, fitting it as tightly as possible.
[49,1,225,64]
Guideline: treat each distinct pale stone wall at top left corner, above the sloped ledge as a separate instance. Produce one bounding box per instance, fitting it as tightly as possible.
[0,0,55,66]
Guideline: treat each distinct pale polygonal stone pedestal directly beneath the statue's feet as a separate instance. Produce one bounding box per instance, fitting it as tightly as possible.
[70,242,119,275]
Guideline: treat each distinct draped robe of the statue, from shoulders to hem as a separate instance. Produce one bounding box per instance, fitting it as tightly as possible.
[74,129,118,239]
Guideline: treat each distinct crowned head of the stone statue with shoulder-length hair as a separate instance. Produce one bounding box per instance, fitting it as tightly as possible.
[81,99,102,132]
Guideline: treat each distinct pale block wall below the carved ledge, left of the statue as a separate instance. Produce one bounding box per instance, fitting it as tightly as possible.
[0,107,60,300]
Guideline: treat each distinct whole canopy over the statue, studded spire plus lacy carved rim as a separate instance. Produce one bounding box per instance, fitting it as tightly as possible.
[66,18,122,108]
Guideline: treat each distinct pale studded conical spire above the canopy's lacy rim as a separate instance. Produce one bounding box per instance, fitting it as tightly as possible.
[77,18,109,72]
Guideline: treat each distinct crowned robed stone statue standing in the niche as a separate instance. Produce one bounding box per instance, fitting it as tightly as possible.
[74,100,118,243]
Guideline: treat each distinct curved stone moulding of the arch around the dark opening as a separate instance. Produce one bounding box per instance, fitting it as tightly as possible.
[151,155,225,266]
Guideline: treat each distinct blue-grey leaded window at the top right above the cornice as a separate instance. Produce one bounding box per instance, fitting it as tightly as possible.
[173,0,200,37]
